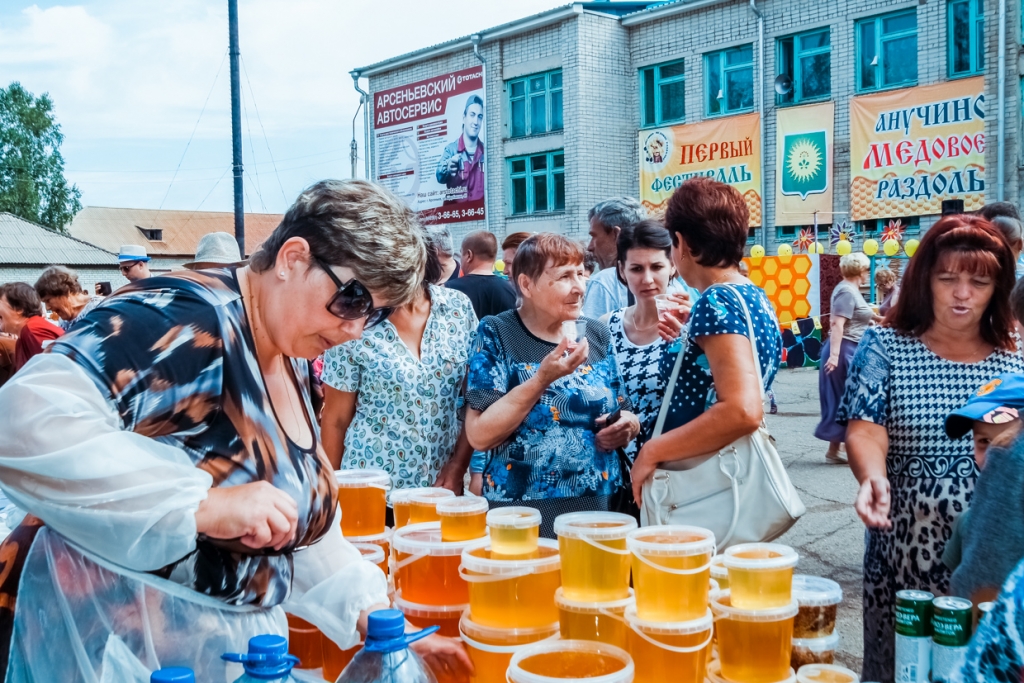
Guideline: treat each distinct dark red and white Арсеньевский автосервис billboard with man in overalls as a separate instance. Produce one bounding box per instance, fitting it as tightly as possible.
[373,65,486,224]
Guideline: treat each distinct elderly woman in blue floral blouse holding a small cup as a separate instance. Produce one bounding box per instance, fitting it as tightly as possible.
[466,232,640,537]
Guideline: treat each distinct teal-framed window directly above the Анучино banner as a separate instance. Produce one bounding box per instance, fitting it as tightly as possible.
[857,9,918,92]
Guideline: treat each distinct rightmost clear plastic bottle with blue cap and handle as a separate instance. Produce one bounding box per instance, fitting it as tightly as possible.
[337,609,438,683]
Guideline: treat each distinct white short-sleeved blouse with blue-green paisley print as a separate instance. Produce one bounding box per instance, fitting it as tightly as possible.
[322,285,476,488]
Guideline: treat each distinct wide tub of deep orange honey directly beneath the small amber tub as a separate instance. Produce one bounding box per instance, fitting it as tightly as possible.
[391,522,474,605]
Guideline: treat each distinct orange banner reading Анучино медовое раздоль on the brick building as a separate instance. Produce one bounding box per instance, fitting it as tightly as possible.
[850,76,985,220]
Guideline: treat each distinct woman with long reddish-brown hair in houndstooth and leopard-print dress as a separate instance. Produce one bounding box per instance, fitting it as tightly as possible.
[839,216,1024,683]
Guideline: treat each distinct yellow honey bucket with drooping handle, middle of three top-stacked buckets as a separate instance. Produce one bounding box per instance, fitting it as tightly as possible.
[626,525,715,623]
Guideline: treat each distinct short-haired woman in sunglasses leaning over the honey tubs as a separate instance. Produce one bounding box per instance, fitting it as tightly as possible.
[0,181,469,681]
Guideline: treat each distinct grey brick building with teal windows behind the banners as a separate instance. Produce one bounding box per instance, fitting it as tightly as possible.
[353,0,1024,249]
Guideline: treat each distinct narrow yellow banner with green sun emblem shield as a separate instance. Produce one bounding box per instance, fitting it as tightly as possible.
[775,101,836,225]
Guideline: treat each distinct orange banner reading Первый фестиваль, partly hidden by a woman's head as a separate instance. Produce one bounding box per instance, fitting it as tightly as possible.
[640,114,761,227]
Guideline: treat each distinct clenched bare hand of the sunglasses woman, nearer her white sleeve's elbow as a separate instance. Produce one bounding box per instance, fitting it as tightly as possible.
[196,481,299,550]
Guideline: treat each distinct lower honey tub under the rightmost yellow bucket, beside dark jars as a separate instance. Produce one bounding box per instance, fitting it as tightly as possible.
[711,584,799,683]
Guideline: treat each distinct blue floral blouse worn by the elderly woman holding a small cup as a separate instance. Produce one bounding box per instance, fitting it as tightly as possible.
[466,310,631,501]
